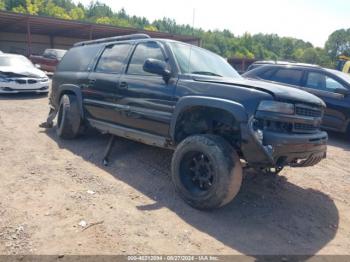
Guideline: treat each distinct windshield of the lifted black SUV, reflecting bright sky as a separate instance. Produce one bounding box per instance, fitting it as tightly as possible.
[170,42,241,78]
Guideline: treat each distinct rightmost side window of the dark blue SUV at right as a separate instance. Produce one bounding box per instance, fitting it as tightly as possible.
[305,72,345,92]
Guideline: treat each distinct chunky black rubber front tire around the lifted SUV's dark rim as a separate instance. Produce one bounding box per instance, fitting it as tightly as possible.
[171,135,242,209]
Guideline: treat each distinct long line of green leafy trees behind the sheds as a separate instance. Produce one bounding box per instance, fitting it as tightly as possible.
[0,0,350,67]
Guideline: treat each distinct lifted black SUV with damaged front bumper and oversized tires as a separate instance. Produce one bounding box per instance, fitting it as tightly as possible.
[50,35,327,209]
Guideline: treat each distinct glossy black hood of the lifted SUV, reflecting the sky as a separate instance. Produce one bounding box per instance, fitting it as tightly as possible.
[193,76,326,107]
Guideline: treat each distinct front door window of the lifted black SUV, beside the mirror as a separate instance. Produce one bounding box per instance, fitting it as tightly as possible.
[127,42,165,75]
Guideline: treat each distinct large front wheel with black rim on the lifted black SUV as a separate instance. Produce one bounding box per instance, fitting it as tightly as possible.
[171,135,242,209]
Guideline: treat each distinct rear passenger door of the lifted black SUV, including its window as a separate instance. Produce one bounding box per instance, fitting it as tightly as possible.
[84,43,131,123]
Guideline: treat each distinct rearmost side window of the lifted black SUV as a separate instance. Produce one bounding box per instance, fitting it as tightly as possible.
[57,45,100,72]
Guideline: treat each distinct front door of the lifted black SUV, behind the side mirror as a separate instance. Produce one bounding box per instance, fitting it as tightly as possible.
[117,40,177,136]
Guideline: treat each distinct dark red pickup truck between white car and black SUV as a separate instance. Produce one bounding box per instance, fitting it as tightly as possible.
[29,49,67,72]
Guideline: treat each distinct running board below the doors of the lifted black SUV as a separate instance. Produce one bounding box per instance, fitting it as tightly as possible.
[87,118,173,148]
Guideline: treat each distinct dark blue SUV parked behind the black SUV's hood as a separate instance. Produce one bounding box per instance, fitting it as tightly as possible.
[243,63,350,134]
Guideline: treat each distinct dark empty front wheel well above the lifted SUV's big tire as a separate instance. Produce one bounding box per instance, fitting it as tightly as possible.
[174,106,240,148]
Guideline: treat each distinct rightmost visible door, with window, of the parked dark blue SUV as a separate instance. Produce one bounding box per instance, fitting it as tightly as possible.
[303,70,350,131]
